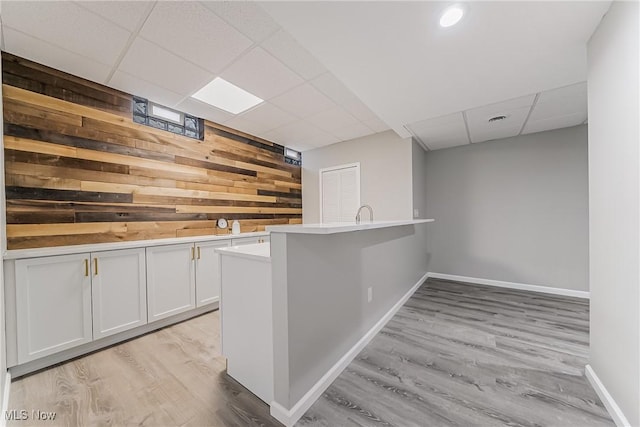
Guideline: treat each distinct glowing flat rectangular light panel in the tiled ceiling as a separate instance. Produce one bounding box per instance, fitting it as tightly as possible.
[191,77,264,114]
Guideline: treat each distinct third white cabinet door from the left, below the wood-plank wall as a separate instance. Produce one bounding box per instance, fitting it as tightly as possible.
[147,243,196,322]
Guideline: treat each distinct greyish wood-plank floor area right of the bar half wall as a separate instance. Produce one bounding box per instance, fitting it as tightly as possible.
[297,279,614,427]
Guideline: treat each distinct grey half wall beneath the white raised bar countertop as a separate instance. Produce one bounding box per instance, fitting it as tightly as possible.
[271,223,433,409]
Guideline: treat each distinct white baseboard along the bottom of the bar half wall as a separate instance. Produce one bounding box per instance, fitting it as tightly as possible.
[270,273,429,427]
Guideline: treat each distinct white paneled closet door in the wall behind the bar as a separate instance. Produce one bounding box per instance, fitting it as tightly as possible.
[320,163,360,223]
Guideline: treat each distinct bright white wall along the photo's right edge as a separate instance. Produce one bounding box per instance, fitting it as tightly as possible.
[587,1,640,426]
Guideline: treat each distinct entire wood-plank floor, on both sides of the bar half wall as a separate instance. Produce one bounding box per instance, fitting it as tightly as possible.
[9,279,613,427]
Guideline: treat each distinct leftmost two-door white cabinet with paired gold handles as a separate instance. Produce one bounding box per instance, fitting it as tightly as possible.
[15,248,147,363]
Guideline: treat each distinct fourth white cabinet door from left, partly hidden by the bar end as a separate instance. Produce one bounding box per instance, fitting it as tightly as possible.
[196,240,229,307]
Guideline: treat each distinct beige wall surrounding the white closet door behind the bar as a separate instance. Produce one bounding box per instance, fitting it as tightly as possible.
[302,131,413,223]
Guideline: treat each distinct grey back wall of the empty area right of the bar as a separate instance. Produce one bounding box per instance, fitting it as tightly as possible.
[424,126,589,291]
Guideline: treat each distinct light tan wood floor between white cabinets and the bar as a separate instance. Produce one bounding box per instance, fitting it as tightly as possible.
[9,311,281,427]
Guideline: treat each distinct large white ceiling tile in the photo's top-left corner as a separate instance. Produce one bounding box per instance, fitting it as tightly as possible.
[2,1,131,65]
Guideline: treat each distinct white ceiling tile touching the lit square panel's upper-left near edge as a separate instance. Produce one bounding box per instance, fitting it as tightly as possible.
[120,37,213,96]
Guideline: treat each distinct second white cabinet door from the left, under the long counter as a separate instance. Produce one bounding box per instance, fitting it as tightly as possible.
[91,248,147,339]
